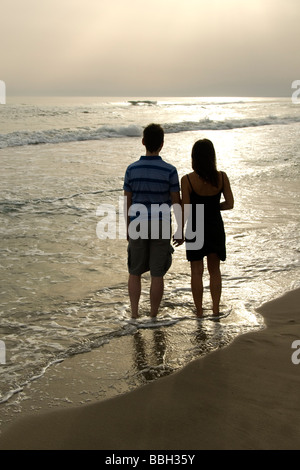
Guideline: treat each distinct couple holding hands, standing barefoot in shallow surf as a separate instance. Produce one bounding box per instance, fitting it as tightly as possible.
[123,124,234,318]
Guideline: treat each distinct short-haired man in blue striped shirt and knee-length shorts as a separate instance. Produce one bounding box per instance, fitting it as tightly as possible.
[124,124,182,318]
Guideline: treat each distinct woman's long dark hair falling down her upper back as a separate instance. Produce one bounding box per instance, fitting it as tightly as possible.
[192,139,219,187]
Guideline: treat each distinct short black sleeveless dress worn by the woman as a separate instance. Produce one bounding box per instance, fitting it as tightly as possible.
[186,173,226,261]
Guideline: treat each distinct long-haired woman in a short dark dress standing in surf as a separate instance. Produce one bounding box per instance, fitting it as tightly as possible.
[181,139,234,317]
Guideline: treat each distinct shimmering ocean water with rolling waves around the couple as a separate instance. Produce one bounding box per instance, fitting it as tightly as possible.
[0,97,300,404]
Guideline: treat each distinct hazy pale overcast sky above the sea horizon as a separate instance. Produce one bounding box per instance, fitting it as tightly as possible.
[0,0,300,96]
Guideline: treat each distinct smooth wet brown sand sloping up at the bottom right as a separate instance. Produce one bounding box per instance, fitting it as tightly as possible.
[0,289,300,450]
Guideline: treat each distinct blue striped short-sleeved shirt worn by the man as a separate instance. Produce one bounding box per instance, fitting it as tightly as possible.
[123,155,180,216]
